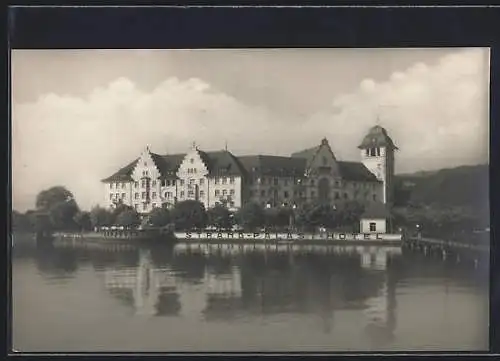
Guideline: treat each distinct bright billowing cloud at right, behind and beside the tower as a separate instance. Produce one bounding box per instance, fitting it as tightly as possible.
[311,49,489,172]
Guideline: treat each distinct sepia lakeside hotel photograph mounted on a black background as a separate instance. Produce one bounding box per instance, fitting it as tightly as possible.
[10,47,490,353]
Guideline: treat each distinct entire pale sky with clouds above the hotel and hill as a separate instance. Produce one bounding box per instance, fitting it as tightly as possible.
[11,48,489,211]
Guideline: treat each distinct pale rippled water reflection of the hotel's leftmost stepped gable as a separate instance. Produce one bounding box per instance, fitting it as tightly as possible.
[105,250,180,315]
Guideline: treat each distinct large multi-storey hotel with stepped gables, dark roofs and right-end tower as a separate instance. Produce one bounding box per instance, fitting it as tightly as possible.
[102,125,397,213]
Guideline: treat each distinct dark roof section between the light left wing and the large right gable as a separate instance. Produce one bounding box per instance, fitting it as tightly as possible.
[238,155,306,177]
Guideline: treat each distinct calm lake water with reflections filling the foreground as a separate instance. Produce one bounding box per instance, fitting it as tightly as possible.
[12,233,489,352]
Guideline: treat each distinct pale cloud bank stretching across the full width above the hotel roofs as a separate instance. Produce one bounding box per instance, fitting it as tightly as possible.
[12,50,488,210]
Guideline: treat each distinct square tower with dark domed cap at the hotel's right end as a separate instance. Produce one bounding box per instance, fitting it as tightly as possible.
[358,125,398,205]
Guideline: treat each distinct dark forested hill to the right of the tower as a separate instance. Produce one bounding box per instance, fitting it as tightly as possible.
[395,165,489,211]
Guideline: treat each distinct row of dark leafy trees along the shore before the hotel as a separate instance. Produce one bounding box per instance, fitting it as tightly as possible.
[12,186,483,241]
